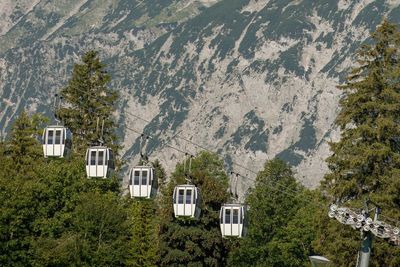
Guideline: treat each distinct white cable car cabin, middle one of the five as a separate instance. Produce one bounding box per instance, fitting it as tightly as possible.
[129,166,157,198]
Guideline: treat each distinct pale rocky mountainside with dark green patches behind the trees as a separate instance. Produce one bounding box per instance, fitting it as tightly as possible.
[0,0,400,193]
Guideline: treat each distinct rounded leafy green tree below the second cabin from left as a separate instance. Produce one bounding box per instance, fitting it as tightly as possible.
[32,191,129,266]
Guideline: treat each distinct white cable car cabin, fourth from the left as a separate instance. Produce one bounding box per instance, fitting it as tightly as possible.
[173,184,201,218]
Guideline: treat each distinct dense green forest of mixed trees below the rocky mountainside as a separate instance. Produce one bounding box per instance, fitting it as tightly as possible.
[0,21,400,266]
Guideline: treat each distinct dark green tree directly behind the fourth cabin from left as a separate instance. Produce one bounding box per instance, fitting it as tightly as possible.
[158,152,228,266]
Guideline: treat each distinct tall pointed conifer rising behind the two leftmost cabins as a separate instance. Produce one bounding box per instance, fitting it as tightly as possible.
[57,51,119,153]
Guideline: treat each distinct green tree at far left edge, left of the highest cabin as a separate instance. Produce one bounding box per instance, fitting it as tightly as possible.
[0,111,47,266]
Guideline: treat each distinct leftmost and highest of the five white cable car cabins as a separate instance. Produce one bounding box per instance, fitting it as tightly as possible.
[42,125,72,158]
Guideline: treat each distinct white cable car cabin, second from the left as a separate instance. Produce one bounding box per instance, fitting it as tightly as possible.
[86,146,115,178]
